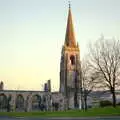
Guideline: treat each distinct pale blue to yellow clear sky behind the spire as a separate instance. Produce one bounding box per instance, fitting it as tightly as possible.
[0,0,120,91]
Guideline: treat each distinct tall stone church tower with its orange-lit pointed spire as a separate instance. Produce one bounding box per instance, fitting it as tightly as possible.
[60,4,81,109]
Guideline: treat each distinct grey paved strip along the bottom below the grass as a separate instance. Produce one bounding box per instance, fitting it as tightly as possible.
[0,116,120,120]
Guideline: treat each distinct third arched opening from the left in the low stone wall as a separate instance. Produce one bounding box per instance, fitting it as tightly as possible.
[32,95,41,110]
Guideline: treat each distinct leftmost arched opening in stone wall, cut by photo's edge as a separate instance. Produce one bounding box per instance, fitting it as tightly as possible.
[0,94,8,111]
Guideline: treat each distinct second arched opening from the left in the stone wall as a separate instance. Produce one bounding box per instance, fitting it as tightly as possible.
[16,95,24,111]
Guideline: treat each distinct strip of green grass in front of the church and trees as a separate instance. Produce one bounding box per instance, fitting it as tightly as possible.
[0,107,120,117]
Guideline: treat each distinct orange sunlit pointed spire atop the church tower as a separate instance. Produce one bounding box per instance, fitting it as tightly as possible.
[65,2,76,47]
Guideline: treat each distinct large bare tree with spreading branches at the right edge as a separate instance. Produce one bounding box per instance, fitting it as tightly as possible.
[89,37,120,107]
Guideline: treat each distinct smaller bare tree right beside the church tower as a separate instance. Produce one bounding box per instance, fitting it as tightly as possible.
[81,60,97,110]
